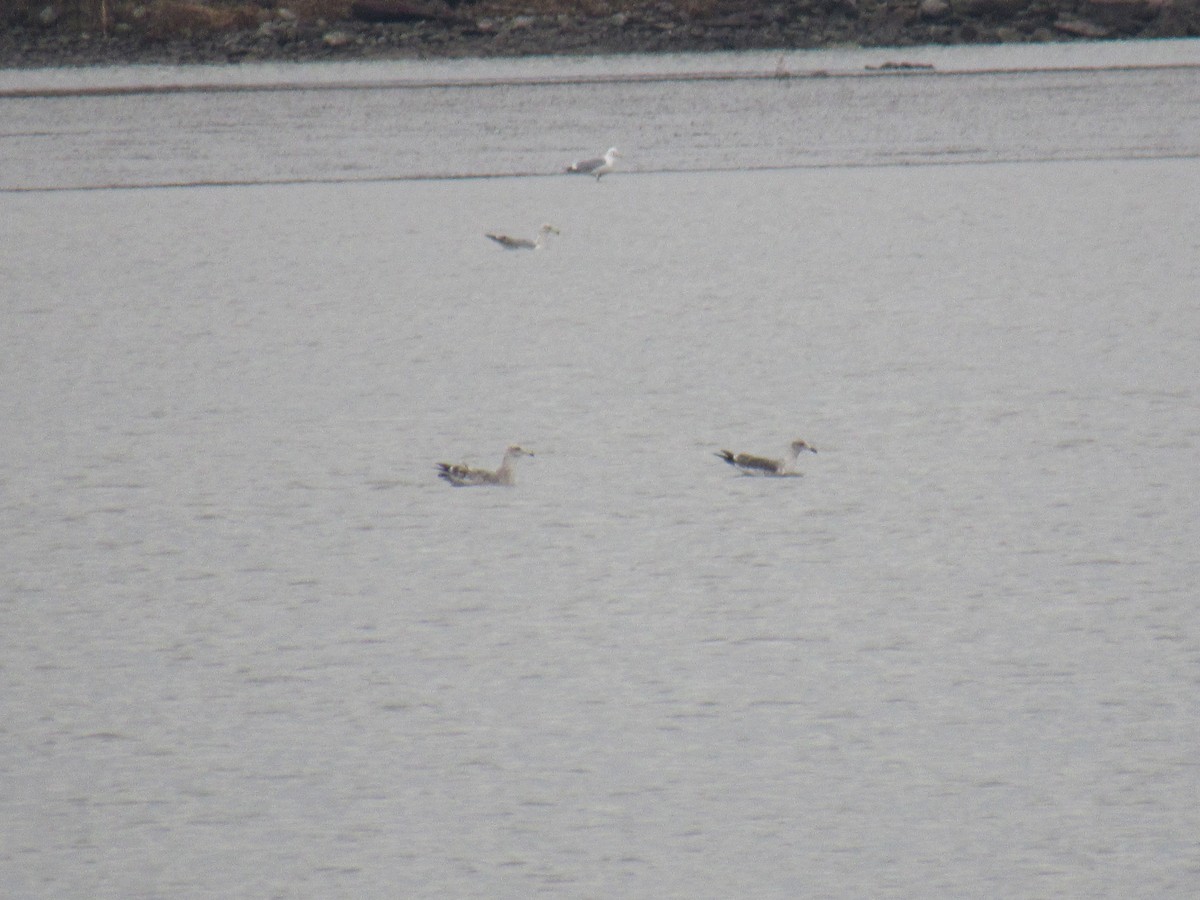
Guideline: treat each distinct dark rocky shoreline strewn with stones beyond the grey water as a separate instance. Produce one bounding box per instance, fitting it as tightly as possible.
[0,0,1200,67]
